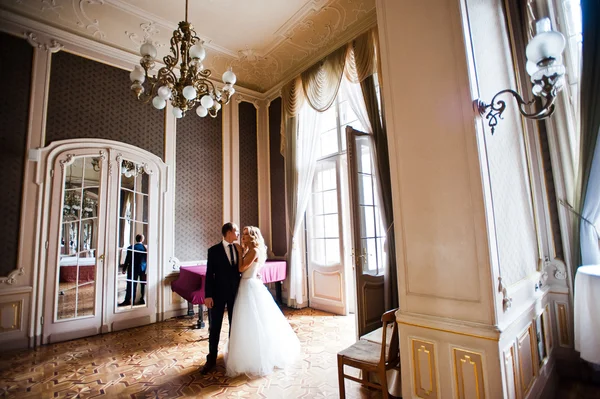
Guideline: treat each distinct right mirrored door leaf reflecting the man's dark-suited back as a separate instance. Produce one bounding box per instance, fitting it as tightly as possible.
[107,153,159,330]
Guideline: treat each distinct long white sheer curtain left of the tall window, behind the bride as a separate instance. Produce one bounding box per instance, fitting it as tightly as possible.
[288,103,321,307]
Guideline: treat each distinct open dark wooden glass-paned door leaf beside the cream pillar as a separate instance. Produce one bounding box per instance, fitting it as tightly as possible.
[346,127,387,336]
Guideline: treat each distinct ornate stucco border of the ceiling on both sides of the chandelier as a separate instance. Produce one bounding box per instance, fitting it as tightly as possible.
[0,0,377,93]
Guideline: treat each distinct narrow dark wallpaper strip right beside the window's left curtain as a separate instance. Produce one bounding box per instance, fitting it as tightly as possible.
[269,98,287,256]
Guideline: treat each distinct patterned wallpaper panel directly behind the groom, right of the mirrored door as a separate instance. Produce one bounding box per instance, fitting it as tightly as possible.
[175,112,223,262]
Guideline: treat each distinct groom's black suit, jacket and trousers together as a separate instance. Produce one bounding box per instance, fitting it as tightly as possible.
[204,242,241,365]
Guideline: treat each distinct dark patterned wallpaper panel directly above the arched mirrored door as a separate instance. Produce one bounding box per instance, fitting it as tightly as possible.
[46,51,164,159]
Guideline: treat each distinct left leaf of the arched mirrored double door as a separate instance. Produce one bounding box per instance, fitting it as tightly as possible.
[44,151,107,342]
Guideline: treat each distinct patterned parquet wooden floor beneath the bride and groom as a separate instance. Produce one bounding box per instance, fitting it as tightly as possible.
[0,309,390,399]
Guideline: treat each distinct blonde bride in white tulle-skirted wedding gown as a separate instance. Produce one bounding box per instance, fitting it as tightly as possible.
[226,226,300,376]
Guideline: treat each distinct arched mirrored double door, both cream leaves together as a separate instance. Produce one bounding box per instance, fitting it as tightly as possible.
[42,144,160,343]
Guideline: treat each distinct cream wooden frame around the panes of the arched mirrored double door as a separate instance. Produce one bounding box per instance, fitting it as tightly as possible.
[35,139,167,343]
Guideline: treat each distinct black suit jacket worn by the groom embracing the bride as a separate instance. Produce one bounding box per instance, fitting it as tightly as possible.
[204,242,241,299]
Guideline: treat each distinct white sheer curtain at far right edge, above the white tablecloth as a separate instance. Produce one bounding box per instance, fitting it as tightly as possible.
[580,131,600,265]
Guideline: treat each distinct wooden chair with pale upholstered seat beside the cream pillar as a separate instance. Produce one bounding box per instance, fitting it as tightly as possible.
[338,309,400,399]
